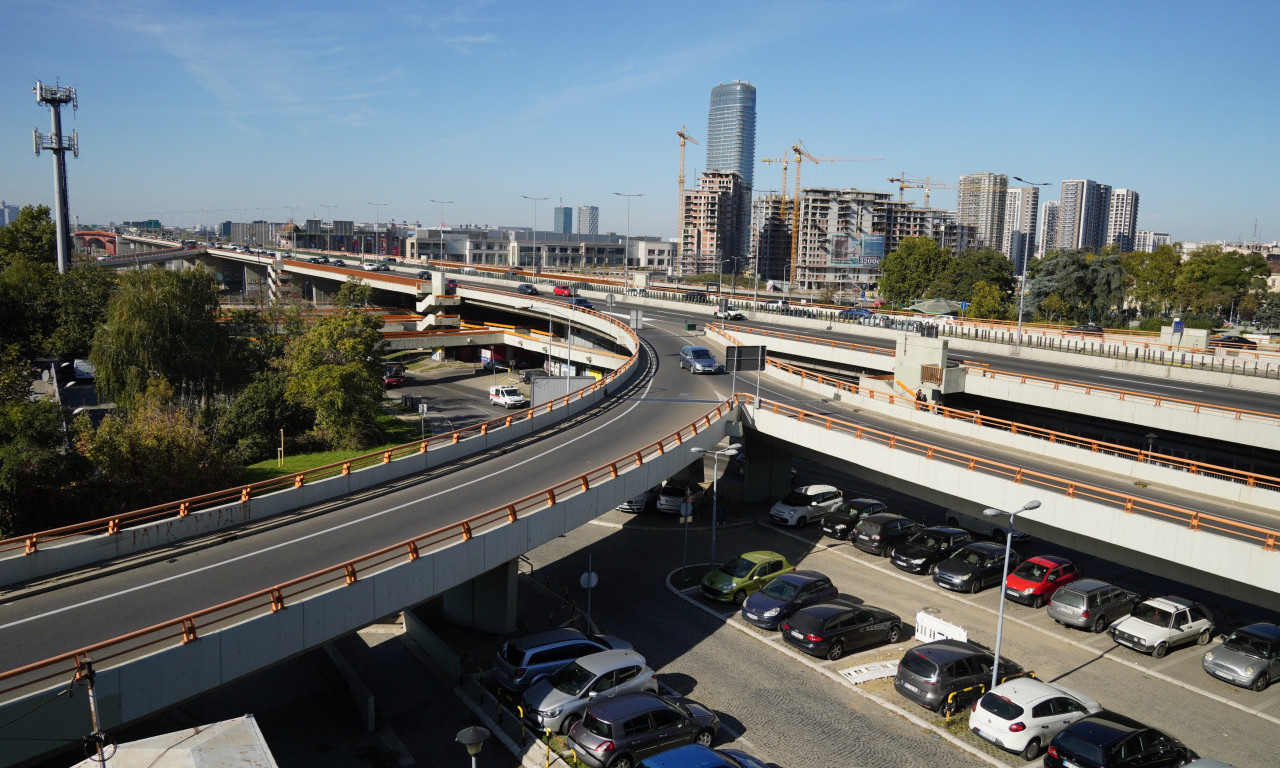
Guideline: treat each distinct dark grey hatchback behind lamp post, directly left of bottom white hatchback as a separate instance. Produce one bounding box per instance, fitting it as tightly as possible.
[893,640,1023,712]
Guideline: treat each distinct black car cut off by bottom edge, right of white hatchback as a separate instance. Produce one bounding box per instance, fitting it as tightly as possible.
[1044,712,1197,768]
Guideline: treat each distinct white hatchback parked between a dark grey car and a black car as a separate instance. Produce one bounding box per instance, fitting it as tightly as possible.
[969,677,1102,760]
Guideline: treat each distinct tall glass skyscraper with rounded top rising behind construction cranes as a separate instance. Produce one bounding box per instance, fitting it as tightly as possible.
[707,81,755,259]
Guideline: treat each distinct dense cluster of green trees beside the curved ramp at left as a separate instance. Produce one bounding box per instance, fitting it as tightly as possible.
[0,206,385,538]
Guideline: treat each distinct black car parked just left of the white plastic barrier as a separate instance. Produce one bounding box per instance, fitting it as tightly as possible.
[778,598,902,660]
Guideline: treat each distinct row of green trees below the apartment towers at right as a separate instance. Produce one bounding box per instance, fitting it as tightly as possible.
[879,237,1280,328]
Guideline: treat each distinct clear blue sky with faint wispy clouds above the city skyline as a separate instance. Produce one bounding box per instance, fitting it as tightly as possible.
[0,0,1280,242]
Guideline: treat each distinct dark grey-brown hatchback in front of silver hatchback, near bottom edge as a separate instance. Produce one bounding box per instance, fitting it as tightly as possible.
[568,691,719,768]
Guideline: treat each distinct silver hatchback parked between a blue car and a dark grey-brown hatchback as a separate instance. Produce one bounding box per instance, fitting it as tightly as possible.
[522,649,658,733]
